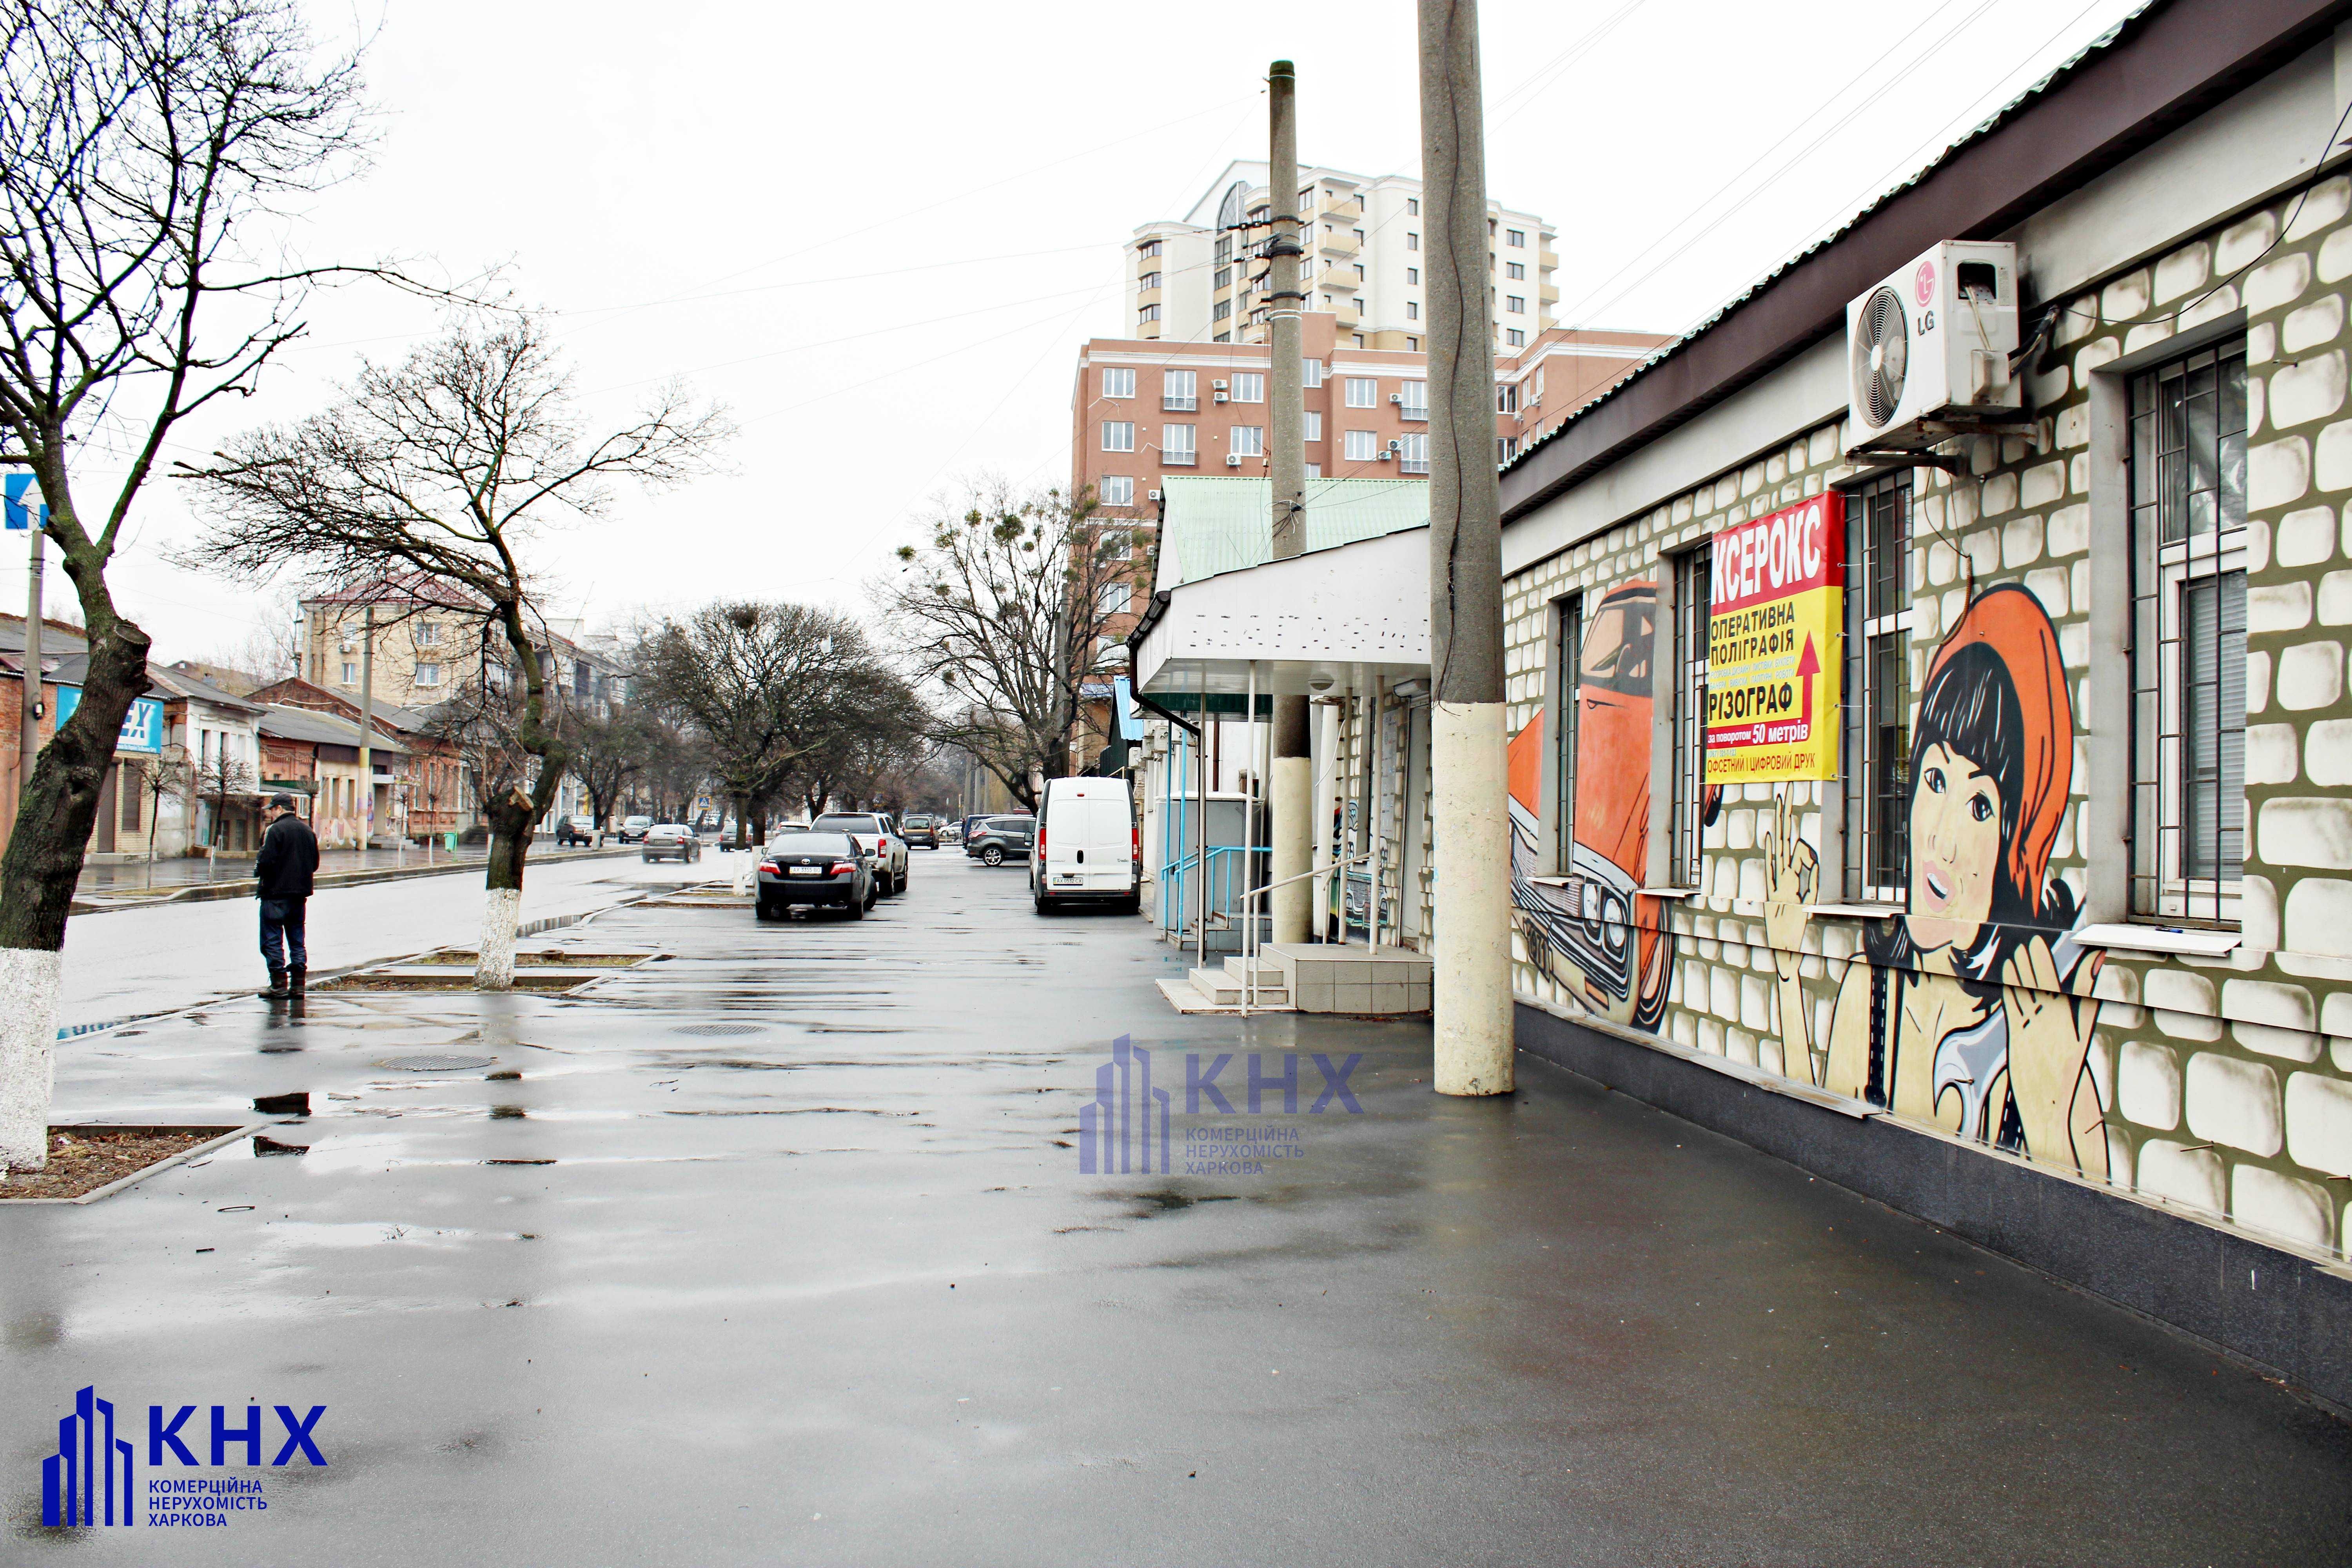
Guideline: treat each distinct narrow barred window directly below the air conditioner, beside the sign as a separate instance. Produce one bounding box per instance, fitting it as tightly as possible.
[1839,468,1912,905]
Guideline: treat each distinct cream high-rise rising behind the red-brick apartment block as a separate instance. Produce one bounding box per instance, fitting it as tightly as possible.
[1127,162,1559,353]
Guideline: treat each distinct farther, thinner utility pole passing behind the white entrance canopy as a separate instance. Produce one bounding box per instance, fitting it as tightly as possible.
[1279,59,1315,943]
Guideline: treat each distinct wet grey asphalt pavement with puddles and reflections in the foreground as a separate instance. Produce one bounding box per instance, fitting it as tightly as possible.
[0,851,2352,1566]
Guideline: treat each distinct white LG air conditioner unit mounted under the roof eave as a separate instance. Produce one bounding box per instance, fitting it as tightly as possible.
[1846,240,2025,451]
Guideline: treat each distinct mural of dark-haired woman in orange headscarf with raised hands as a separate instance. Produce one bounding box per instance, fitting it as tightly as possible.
[1764,583,2107,1178]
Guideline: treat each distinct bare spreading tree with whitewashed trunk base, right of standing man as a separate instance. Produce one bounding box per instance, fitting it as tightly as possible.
[186,313,729,990]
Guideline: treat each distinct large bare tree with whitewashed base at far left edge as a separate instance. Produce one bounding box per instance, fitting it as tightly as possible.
[0,0,395,1169]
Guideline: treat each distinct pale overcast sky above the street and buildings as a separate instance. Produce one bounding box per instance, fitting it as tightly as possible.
[87,0,2138,661]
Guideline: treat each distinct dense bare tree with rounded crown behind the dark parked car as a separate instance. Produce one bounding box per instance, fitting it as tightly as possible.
[642,602,889,844]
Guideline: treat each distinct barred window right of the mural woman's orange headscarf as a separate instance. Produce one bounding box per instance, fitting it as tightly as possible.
[2131,341,2246,924]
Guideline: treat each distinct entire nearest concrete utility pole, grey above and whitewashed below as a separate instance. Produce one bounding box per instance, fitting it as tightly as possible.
[1418,0,1515,1096]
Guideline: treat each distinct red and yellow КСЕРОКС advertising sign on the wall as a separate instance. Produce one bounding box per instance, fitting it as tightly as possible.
[1708,491,1846,783]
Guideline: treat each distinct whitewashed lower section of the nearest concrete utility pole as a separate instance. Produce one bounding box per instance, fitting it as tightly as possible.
[1430,703,1517,1096]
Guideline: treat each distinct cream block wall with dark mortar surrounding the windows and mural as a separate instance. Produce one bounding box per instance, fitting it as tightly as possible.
[1505,179,2352,1253]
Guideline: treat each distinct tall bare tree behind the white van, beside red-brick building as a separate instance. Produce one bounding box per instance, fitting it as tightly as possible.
[873,484,1134,809]
